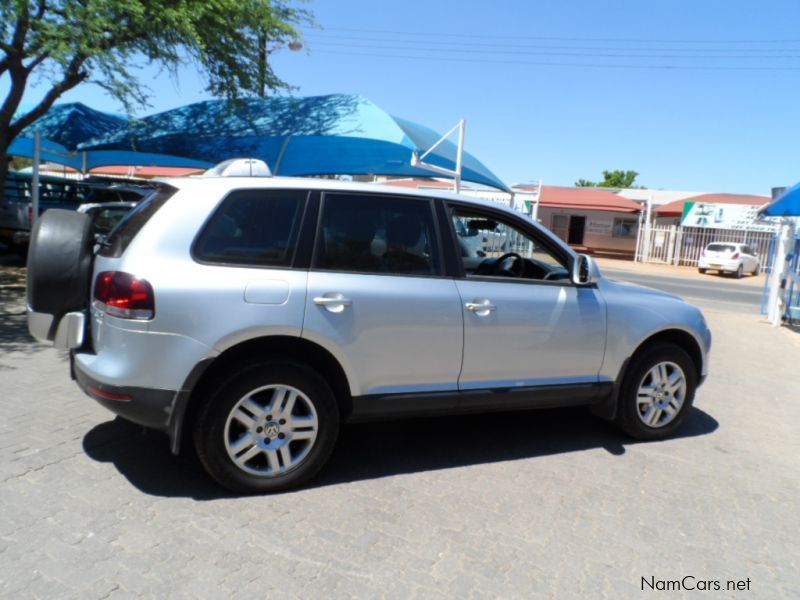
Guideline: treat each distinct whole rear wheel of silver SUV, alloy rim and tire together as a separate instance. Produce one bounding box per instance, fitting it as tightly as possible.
[194,362,339,493]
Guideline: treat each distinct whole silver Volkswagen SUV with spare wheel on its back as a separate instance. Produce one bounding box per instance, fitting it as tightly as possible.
[28,168,711,492]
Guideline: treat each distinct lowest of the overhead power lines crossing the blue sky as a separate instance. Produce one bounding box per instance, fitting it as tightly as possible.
[318,50,800,71]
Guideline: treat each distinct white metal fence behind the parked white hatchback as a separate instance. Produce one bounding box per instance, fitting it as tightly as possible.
[636,225,775,271]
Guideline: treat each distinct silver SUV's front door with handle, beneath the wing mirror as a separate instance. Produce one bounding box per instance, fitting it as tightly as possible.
[452,208,606,390]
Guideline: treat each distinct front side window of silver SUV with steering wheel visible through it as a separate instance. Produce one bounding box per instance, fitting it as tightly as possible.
[452,208,569,281]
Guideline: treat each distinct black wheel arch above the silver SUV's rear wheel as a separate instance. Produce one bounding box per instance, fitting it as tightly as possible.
[169,335,353,454]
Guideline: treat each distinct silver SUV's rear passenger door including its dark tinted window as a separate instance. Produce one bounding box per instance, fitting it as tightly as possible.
[302,192,463,396]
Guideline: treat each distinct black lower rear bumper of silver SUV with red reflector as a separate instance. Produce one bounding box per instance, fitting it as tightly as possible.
[73,354,176,433]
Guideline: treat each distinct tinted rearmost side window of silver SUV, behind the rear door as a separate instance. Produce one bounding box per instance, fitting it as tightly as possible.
[194,190,308,267]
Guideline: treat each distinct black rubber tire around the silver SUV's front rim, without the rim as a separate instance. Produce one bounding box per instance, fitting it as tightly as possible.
[616,344,697,440]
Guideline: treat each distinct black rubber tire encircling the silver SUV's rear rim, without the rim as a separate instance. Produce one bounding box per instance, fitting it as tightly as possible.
[193,360,339,494]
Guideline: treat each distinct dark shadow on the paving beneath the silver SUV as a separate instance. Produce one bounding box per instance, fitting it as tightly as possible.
[83,408,719,500]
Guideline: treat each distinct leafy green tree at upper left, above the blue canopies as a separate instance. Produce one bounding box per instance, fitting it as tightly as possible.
[0,0,311,199]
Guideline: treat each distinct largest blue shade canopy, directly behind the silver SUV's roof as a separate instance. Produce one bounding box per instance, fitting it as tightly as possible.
[79,94,509,191]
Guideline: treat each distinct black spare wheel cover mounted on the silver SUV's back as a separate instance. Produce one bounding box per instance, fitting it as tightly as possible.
[27,208,94,339]
